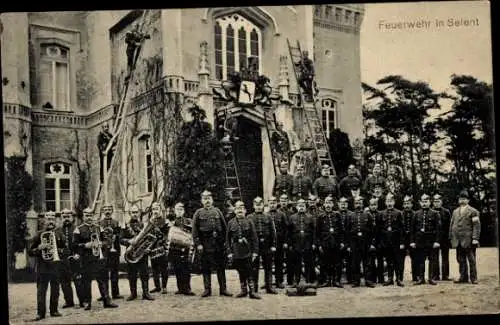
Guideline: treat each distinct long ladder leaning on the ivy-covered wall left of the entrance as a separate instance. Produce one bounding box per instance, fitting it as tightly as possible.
[91,10,149,213]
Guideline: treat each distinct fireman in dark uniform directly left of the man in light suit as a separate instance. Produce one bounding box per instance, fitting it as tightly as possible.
[432,194,451,281]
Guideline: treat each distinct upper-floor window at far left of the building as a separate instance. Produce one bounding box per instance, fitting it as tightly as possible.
[40,44,70,110]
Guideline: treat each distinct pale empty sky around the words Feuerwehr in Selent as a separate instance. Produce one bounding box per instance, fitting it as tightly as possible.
[361,1,493,97]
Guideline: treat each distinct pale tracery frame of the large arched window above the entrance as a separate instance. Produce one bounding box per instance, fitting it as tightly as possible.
[213,13,263,80]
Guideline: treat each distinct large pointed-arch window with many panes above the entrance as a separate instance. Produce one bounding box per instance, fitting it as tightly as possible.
[214,14,262,80]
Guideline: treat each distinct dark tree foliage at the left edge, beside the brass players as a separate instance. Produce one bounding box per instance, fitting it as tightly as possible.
[4,156,33,276]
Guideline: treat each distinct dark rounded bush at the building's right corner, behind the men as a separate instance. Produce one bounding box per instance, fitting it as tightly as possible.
[328,129,354,177]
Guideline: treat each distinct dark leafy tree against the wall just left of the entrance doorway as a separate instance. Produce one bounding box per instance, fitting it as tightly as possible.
[172,105,225,214]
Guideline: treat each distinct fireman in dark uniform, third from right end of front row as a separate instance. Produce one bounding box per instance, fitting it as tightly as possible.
[410,194,441,285]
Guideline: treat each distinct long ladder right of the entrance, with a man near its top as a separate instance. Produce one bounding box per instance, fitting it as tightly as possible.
[286,39,336,176]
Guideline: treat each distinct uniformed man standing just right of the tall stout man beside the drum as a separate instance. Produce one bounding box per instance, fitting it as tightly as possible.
[226,201,261,299]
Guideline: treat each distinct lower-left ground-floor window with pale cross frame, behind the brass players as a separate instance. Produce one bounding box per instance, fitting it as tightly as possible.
[45,162,73,211]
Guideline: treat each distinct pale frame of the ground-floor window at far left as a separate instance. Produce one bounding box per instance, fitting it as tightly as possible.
[43,160,74,212]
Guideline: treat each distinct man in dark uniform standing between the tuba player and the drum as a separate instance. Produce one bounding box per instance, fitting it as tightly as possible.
[149,202,170,295]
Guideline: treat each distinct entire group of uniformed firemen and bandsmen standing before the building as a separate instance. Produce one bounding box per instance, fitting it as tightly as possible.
[29,163,480,320]
